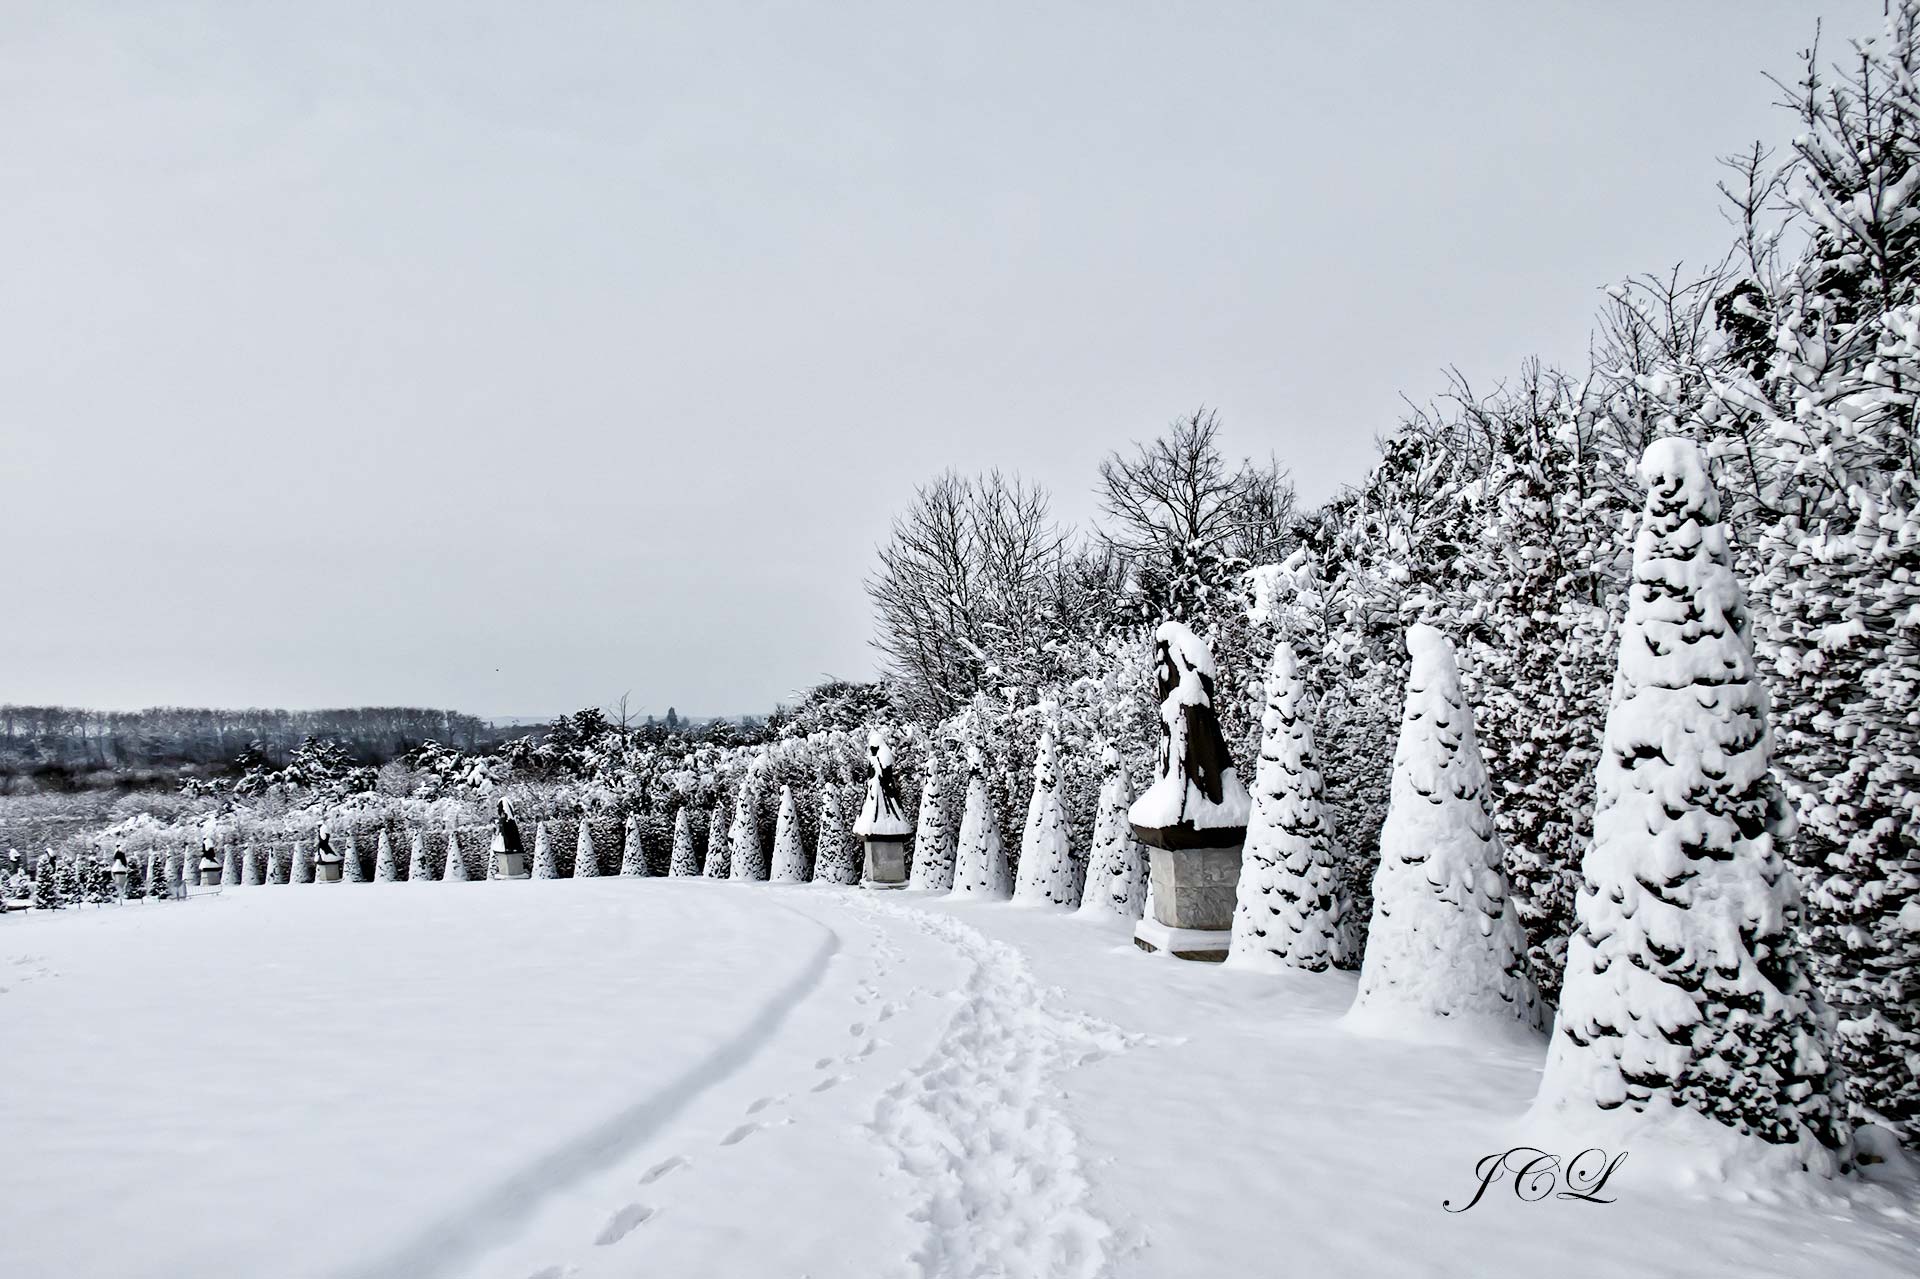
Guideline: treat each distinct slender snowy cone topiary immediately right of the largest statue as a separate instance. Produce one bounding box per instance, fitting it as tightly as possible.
[1227,640,1340,972]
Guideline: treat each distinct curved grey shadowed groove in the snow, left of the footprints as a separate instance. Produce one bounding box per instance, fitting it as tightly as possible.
[336,906,841,1279]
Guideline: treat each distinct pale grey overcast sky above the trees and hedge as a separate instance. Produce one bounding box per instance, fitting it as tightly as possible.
[0,0,1880,714]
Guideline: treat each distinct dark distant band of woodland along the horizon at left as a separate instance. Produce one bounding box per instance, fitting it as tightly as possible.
[0,705,510,789]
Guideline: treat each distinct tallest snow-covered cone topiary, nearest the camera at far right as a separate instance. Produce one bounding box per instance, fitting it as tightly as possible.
[1538,438,1843,1171]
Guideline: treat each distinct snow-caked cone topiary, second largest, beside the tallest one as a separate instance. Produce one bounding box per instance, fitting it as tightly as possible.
[1348,624,1544,1035]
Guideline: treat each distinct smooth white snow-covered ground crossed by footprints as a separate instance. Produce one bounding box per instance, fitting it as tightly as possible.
[0,878,1920,1279]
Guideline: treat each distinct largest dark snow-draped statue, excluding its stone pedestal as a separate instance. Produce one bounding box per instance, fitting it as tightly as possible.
[1127,622,1252,849]
